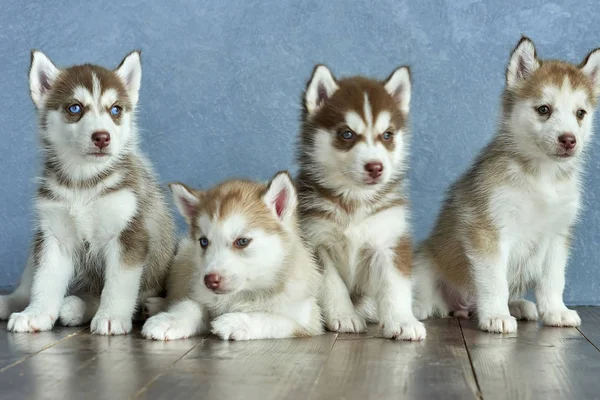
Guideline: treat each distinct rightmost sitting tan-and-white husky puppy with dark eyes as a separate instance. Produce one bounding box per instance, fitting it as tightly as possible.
[414,37,600,333]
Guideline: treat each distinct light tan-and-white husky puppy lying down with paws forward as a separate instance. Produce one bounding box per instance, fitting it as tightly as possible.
[142,172,322,340]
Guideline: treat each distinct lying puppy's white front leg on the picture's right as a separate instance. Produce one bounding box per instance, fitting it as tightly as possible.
[211,312,304,340]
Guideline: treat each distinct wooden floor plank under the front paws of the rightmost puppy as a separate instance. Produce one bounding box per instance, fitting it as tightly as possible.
[461,320,600,400]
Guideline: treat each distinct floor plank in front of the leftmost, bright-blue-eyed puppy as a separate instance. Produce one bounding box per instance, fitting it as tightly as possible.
[0,327,203,400]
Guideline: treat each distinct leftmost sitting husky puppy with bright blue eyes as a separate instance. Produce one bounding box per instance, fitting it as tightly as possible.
[0,51,175,335]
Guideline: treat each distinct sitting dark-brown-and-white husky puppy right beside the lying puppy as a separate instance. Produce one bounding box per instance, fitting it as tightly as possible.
[298,65,425,340]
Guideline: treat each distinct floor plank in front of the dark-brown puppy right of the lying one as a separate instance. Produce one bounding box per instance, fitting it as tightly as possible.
[309,318,477,400]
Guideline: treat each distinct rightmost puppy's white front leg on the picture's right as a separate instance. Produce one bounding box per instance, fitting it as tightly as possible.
[535,235,581,326]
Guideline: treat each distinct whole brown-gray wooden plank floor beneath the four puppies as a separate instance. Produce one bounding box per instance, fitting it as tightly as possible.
[0,307,600,400]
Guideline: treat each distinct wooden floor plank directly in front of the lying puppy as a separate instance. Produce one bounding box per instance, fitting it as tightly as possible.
[138,333,336,400]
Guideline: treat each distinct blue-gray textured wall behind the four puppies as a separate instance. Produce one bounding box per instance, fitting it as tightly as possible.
[0,0,600,304]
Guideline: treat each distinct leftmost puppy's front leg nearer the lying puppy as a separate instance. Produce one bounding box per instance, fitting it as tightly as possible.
[90,238,145,335]
